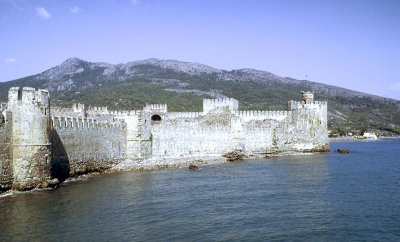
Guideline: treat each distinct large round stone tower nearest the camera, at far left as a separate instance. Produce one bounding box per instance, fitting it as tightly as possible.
[8,87,51,190]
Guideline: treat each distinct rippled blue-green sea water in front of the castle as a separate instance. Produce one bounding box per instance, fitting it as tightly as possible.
[0,141,400,241]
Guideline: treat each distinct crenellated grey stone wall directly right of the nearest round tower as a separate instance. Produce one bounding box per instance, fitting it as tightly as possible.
[51,117,126,177]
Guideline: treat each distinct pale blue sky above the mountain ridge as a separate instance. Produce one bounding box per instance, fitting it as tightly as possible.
[0,0,400,99]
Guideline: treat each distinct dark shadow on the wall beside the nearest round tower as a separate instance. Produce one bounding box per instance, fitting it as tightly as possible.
[51,129,70,182]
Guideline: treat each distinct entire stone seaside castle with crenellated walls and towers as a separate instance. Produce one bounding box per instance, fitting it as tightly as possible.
[0,87,329,191]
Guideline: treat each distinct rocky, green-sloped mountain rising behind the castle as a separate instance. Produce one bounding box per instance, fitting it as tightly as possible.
[0,58,400,133]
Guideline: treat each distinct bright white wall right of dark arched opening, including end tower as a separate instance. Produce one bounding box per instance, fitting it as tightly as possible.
[147,99,329,158]
